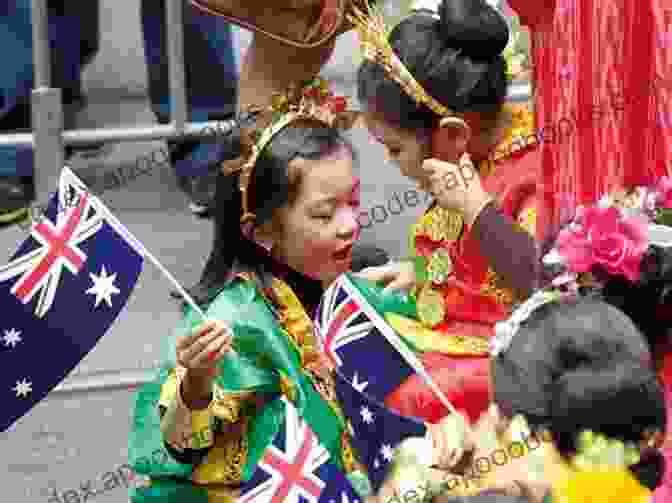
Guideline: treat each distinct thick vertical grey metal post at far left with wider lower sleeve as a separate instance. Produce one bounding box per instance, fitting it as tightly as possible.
[31,0,63,207]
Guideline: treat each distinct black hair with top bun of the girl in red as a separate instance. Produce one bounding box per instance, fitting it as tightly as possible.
[357,0,509,130]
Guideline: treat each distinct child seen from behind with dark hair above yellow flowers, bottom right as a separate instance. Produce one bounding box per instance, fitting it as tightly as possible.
[475,298,666,503]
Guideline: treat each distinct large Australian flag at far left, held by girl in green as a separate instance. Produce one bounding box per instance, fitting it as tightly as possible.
[0,167,143,431]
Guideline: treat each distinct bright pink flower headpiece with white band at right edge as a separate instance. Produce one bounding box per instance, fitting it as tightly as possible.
[490,177,672,357]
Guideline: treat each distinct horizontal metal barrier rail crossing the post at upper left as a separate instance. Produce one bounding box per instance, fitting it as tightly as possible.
[0,120,238,148]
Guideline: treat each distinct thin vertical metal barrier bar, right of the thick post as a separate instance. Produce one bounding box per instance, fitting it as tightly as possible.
[166,0,188,131]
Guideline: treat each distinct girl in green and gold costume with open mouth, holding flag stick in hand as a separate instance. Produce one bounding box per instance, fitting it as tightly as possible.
[130,82,462,503]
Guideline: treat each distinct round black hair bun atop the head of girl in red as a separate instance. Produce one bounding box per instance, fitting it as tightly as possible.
[439,0,509,59]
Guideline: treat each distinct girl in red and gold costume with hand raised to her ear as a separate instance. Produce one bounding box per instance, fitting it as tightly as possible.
[358,0,540,428]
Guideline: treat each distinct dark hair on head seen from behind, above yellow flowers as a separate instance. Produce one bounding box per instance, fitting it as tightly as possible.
[493,297,666,489]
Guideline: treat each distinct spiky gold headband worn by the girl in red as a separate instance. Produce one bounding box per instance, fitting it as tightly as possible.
[348,2,457,122]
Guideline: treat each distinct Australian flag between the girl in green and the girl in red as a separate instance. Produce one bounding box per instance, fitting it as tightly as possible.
[315,274,415,402]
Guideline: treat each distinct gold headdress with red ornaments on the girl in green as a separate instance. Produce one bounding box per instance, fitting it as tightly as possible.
[225,78,358,224]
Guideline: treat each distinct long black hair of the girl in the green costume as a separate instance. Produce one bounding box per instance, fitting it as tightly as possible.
[190,120,357,304]
